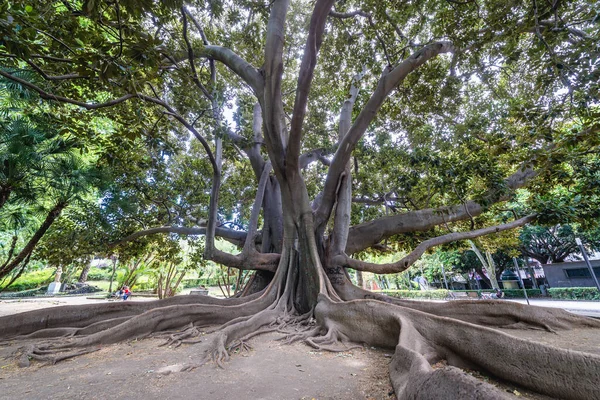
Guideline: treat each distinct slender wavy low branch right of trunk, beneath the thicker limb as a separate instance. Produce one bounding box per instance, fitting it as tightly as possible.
[334,215,535,274]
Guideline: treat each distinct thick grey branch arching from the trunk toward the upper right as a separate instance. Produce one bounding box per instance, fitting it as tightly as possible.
[315,42,454,234]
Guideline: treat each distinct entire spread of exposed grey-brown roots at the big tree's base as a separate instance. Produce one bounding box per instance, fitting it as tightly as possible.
[5,282,600,400]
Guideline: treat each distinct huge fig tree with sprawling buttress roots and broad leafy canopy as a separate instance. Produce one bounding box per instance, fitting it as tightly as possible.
[0,0,600,399]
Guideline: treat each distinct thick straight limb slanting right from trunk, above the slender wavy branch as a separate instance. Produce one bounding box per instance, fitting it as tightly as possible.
[346,168,537,254]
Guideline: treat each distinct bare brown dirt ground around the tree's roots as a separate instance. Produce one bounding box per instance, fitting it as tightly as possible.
[0,300,600,400]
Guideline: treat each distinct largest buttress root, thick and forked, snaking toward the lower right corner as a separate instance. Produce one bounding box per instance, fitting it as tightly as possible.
[315,296,600,400]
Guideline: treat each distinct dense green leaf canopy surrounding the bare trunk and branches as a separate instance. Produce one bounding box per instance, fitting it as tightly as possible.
[0,1,600,290]
